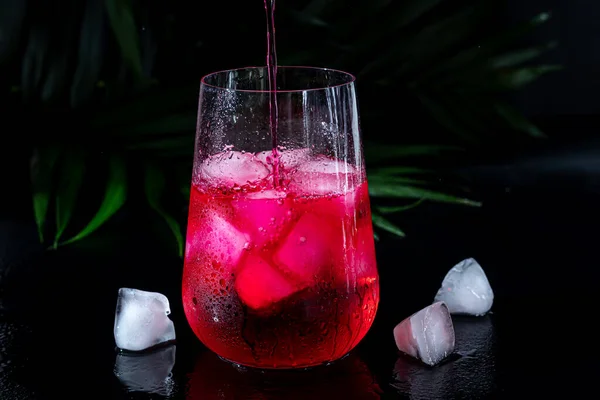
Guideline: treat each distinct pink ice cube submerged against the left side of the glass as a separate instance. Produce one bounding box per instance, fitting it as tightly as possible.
[185,210,249,274]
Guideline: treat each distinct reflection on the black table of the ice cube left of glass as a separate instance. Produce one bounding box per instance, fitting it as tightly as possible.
[115,345,176,397]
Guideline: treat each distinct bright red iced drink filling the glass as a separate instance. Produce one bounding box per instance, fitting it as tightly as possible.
[183,149,379,368]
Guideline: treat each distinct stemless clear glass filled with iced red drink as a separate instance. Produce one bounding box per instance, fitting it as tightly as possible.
[182,67,379,369]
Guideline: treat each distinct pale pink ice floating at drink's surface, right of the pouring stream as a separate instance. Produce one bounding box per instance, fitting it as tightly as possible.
[290,156,358,195]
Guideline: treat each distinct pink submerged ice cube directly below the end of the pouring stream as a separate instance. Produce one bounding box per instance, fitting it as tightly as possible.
[231,189,293,246]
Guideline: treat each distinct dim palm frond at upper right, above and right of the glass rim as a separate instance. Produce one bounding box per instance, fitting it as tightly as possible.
[280,0,560,144]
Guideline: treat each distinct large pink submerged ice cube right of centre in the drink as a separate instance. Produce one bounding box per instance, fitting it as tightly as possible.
[273,214,342,283]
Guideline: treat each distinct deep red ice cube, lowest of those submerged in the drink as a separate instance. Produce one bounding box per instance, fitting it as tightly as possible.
[235,255,297,310]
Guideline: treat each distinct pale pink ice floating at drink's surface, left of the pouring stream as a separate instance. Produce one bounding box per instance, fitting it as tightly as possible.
[198,150,270,186]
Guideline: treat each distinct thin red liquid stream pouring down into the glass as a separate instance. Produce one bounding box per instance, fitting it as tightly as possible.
[265,0,280,187]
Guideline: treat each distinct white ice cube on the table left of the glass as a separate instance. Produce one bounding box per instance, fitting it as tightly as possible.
[114,288,175,351]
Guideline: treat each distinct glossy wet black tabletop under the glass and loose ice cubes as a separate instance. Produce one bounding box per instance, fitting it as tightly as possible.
[0,185,600,400]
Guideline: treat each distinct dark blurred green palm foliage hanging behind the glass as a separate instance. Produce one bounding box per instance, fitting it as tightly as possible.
[0,0,558,255]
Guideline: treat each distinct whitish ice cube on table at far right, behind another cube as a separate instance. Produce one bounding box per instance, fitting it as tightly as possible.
[434,258,494,316]
